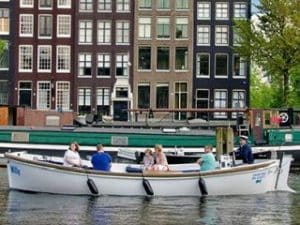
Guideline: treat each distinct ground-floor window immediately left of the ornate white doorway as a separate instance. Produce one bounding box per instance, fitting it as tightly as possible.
[97,88,110,115]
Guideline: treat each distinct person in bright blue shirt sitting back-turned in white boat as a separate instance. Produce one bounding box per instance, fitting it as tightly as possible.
[91,144,112,171]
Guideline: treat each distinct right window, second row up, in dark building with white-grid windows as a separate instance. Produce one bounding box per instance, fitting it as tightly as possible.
[56,45,71,73]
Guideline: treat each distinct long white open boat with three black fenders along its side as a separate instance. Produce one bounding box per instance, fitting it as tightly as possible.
[5,152,293,196]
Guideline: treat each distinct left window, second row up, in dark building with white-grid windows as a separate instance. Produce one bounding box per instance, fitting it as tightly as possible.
[19,45,32,72]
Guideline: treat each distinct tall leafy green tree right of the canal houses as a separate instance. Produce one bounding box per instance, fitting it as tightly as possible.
[234,0,300,107]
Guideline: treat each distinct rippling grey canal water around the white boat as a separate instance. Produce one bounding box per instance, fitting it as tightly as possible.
[0,168,300,225]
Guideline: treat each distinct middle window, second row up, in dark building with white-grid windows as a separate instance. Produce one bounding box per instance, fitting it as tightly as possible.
[38,45,52,72]
